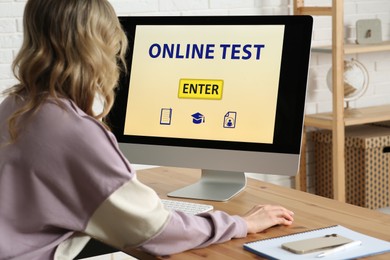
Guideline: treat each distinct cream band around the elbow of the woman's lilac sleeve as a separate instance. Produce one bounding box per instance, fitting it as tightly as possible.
[85,177,170,251]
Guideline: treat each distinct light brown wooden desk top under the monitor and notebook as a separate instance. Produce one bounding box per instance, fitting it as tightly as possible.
[134,167,390,260]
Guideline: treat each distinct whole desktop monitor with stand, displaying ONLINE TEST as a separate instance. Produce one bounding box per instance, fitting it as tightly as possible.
[108,16,312,201]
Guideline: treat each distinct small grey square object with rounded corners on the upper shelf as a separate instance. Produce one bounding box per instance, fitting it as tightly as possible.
[356,19,382,44]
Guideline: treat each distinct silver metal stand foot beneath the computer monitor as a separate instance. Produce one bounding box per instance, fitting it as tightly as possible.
[168,170,246,201]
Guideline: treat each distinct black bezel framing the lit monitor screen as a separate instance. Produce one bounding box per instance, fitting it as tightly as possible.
[107,15,312,154]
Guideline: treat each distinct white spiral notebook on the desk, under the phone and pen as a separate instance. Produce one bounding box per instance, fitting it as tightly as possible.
[244,225,390,260]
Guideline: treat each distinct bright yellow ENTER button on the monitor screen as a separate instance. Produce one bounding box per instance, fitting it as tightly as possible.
[179,79,223,100]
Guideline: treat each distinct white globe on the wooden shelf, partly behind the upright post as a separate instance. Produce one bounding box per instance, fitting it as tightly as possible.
[326,59,369,108]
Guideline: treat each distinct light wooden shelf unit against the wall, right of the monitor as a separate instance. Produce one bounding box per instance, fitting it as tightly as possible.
[293,0,390,202]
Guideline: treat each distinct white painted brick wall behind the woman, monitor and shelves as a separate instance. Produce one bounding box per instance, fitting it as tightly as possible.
[0,0,390,191]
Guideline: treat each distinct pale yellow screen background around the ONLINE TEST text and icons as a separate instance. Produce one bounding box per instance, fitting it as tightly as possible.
[124,25,284,143]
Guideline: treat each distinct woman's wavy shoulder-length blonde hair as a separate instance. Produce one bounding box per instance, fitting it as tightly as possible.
[7,0,127,141]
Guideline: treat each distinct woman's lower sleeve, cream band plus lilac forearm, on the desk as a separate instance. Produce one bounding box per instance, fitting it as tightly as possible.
[85,175,247,255]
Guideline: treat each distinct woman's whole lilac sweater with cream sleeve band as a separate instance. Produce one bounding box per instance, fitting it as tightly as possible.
[0,97,247,260]
